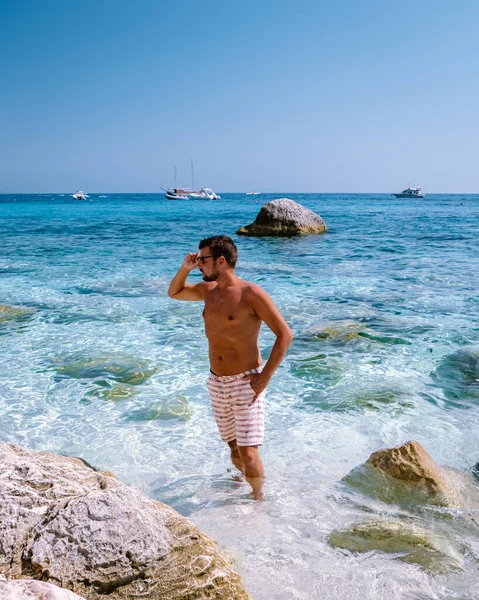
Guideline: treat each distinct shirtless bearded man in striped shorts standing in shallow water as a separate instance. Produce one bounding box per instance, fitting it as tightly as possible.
[168,235,293,499]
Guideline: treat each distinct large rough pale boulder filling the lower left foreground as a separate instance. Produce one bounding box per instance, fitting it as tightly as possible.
[0,443,250,600]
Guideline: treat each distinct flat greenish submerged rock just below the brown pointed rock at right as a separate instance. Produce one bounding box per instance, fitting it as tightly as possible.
[328,520,463,573]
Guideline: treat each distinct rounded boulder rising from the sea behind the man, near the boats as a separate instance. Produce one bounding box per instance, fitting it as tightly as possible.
[236,198,326,236]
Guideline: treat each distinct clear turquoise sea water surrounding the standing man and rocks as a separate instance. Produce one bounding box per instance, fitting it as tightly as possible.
[0,194,479,600]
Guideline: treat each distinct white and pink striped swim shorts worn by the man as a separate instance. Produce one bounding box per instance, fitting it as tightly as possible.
[207,367,265,446]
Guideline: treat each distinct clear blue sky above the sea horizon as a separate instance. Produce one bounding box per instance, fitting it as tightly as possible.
[0,0,479,193]
